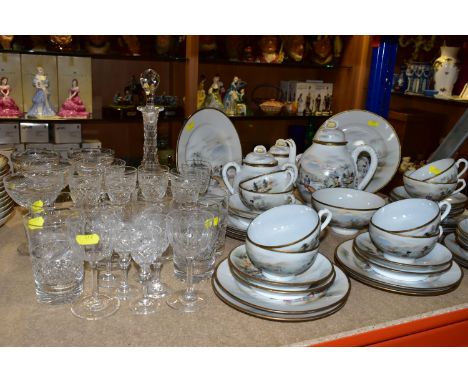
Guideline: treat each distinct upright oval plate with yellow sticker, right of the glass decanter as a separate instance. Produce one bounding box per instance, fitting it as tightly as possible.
[177,108,242,176]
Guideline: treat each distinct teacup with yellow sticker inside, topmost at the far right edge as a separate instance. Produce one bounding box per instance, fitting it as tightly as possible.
[410,158,468,183]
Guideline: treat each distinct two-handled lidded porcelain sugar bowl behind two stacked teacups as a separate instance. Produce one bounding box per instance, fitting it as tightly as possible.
[222,146,297,195]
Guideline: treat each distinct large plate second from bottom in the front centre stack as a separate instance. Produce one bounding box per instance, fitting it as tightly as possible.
[213,259,350,314]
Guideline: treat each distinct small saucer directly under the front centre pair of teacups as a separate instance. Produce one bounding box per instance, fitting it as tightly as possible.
[228,245,333,290]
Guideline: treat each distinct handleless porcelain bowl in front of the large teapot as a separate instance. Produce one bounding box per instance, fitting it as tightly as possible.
[312,188,385,235]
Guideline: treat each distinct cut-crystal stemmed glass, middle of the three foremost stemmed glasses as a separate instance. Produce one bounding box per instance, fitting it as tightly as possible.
[130,213,169,315]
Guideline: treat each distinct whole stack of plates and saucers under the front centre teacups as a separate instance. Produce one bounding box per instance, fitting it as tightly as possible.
[212,245,350,322]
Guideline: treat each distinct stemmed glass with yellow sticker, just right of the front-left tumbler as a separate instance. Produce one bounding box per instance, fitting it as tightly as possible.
[70,206,120,320]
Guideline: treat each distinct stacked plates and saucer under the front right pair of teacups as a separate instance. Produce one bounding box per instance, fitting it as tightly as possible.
[335,232,463,296]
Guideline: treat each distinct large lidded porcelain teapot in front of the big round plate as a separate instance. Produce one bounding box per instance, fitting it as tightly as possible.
[296,120,378,200]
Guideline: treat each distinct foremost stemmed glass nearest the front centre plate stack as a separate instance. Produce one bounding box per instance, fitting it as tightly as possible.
[167,208,215,312]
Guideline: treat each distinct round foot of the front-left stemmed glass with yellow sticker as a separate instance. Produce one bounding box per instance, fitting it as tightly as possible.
[71,294,120,320]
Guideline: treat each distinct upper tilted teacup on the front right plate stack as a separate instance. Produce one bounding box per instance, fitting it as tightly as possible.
[369,198,451,237]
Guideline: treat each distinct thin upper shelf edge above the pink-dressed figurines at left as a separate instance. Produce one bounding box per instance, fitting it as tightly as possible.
[0,49,187,63]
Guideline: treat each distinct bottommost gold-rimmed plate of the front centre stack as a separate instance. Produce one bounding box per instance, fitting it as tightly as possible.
[211,278,346,322]
